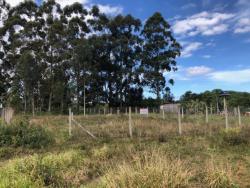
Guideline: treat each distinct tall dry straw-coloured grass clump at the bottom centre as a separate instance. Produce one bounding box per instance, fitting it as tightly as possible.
[98,151,191,188]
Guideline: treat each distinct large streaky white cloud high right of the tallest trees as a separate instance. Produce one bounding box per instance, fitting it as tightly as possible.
[173,11,235,36]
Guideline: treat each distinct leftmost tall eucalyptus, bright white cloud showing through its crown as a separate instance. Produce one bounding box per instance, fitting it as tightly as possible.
[0,1,40,113]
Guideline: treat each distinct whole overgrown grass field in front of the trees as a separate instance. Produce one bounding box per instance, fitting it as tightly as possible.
[0,114,250,188]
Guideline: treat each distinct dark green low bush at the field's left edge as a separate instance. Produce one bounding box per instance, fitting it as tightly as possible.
[0,122,54,149]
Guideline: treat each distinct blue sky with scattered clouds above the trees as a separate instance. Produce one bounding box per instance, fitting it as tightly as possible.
[4,0,250,99]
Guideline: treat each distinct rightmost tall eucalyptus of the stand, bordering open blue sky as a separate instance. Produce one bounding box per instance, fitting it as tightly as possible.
[141,12,181,99]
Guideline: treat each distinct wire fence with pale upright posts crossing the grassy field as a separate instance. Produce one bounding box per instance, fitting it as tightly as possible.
[66,106,250,138]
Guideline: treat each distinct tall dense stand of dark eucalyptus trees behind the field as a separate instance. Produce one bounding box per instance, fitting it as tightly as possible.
[0,0,181,112]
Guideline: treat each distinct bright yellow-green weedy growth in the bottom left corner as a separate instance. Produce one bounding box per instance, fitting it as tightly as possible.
[0,151,83,188]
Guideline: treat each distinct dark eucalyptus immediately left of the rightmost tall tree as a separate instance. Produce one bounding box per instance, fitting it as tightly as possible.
[107,15,141,106]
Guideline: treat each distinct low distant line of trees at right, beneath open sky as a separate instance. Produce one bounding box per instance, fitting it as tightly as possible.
[180,89,250,112]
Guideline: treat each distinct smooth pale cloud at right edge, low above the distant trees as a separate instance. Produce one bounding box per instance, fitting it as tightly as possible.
[208,69,250,84]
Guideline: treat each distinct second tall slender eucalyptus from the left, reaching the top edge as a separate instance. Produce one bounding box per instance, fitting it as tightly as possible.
[39,0,68,112]
